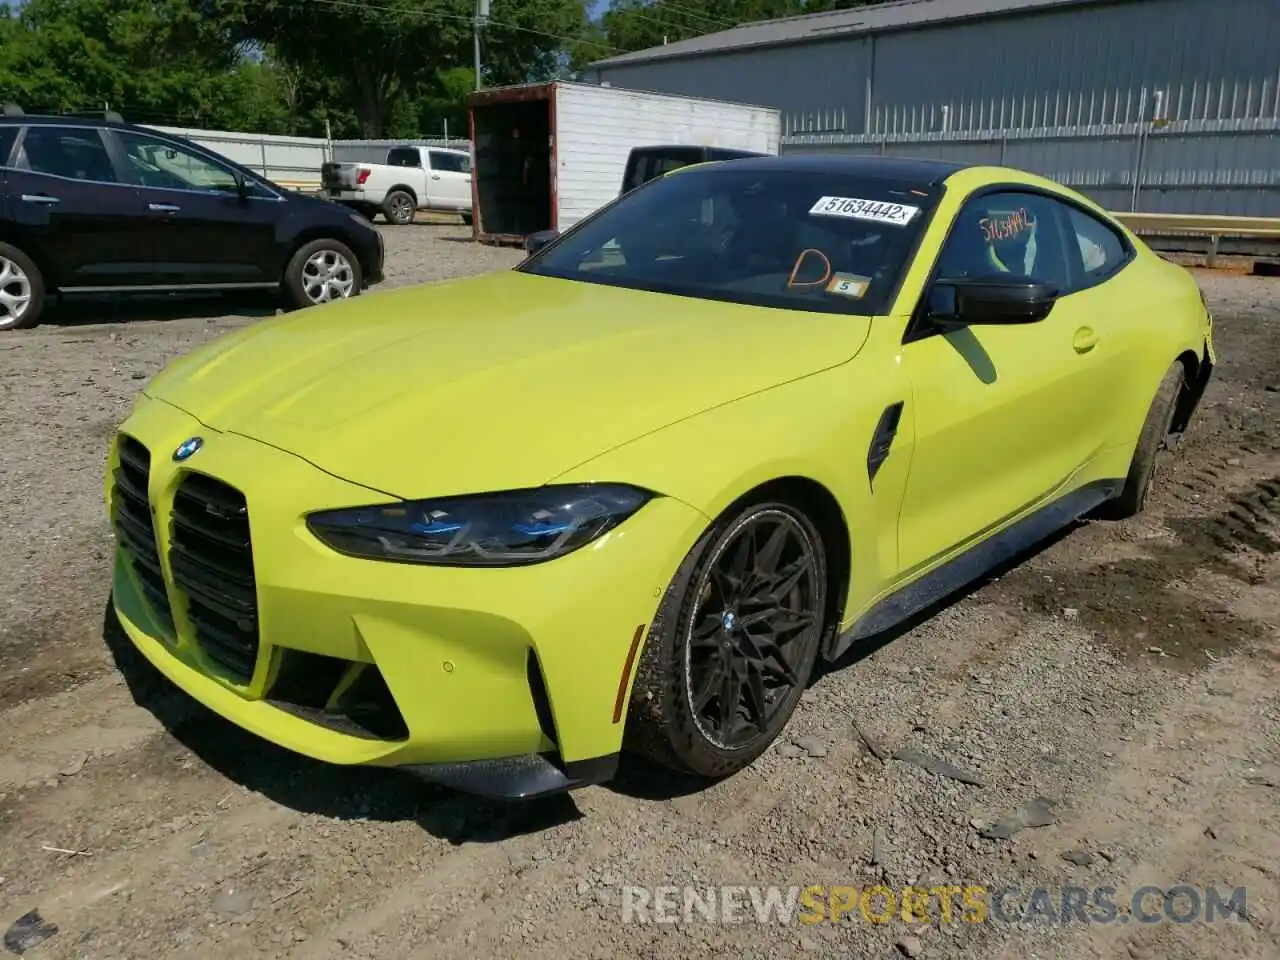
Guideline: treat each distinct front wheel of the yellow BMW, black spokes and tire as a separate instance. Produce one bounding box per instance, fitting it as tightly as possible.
[625,500,827,780]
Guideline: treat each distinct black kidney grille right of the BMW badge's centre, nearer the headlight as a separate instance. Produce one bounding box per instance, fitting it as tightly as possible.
[169,474,259,682]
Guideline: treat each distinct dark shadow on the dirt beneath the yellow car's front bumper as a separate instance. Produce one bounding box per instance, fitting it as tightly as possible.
[102,600,582,845]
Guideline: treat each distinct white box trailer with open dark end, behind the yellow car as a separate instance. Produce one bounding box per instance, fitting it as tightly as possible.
[468,81,782,243]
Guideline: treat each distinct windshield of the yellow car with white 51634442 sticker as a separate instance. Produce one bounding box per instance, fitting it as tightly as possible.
[517,164,938,315]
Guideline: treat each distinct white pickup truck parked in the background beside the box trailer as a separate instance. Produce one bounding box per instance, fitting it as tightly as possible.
[320,146,471,224]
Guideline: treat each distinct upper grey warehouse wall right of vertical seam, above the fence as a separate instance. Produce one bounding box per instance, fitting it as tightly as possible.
[865,0,1280,133]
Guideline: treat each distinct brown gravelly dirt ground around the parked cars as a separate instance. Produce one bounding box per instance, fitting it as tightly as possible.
[0,225,1280,960]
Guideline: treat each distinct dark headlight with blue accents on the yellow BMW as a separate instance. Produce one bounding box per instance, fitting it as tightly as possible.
[307,484,654,567]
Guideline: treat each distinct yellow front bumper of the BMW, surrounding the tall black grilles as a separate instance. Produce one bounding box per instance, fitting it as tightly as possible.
[106,397,707,796]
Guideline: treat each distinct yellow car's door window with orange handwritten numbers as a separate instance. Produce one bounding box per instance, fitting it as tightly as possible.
[938,192,1071,291]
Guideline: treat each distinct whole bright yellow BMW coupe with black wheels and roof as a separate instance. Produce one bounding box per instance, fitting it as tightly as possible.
[106,156,1215,799]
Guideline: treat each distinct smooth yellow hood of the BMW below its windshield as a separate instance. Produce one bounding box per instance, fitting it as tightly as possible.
[145,270,870,498]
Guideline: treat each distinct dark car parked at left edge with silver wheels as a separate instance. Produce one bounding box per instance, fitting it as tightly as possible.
[0,106,384,330]
